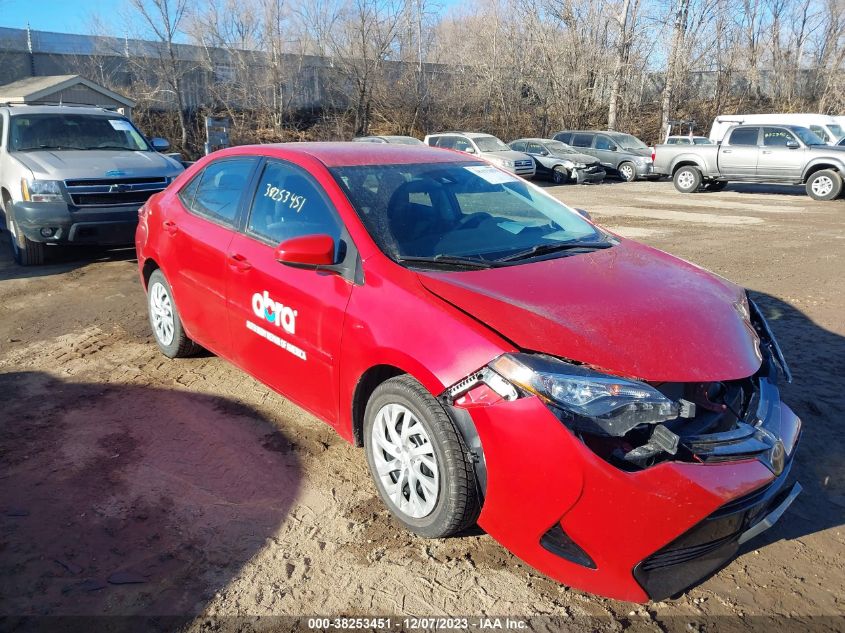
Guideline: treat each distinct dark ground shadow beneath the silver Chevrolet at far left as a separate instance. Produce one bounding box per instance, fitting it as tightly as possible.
[0,228,135,281]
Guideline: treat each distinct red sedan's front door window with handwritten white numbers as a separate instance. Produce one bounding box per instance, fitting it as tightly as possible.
[247,161,341,244]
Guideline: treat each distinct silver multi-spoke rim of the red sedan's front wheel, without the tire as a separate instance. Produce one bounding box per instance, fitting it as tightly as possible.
[371,403,440,519]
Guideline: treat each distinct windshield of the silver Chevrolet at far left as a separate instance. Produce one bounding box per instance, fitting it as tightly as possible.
[9,114,151,152]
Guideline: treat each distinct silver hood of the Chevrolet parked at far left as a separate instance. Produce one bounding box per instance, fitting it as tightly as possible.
[14,150,182,180]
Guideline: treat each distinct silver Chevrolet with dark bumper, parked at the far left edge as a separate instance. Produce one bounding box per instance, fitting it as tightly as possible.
[0,105,183,266]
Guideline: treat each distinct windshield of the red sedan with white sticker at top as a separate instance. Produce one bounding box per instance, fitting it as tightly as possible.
[332,163,606,262]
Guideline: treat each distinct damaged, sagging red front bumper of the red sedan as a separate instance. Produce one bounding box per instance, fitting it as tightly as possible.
[467,388,800,602]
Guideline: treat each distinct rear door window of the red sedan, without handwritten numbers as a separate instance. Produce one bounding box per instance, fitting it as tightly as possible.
[179,158,256,226]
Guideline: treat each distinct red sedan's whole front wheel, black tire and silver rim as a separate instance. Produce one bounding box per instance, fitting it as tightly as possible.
[364,375,480,538]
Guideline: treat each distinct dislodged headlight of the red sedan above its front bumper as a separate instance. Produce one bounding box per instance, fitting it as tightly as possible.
[489,353,680,437]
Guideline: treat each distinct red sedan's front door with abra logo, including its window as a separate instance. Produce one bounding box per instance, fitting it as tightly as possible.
[228,159,358,422]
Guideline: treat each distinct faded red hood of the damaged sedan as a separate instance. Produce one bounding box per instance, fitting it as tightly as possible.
[418,240,761,382]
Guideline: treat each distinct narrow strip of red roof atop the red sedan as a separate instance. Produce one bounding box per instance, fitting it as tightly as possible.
[209,141,478,167]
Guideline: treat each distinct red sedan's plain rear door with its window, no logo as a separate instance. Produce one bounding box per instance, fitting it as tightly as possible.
[159,157,258,357]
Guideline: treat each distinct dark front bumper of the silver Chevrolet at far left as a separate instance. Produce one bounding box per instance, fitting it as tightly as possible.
[12,202,141,245]
